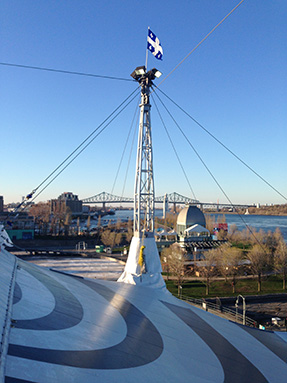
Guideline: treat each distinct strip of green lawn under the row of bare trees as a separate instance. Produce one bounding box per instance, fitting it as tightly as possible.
[166,275,287,298]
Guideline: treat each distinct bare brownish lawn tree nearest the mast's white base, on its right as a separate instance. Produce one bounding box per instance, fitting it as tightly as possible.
[161,243,188,295]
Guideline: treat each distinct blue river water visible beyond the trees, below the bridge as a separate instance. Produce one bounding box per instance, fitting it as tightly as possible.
[103,209,287,242]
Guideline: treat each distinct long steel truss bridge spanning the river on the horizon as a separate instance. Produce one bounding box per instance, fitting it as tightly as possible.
[82,192,254,210]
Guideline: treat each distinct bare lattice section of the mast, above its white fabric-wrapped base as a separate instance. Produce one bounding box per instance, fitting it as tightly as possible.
[134,76,155,236]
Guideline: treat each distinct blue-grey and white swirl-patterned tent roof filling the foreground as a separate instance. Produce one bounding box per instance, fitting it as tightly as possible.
[0,244,287,383]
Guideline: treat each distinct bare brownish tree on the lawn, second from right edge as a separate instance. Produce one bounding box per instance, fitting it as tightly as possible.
[247,243,269,292]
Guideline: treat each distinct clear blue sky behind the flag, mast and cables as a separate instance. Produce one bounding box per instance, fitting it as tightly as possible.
[0,0,287,207]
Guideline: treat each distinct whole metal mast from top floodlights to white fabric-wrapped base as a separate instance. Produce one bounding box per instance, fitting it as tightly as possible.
[118,66,166,289]
